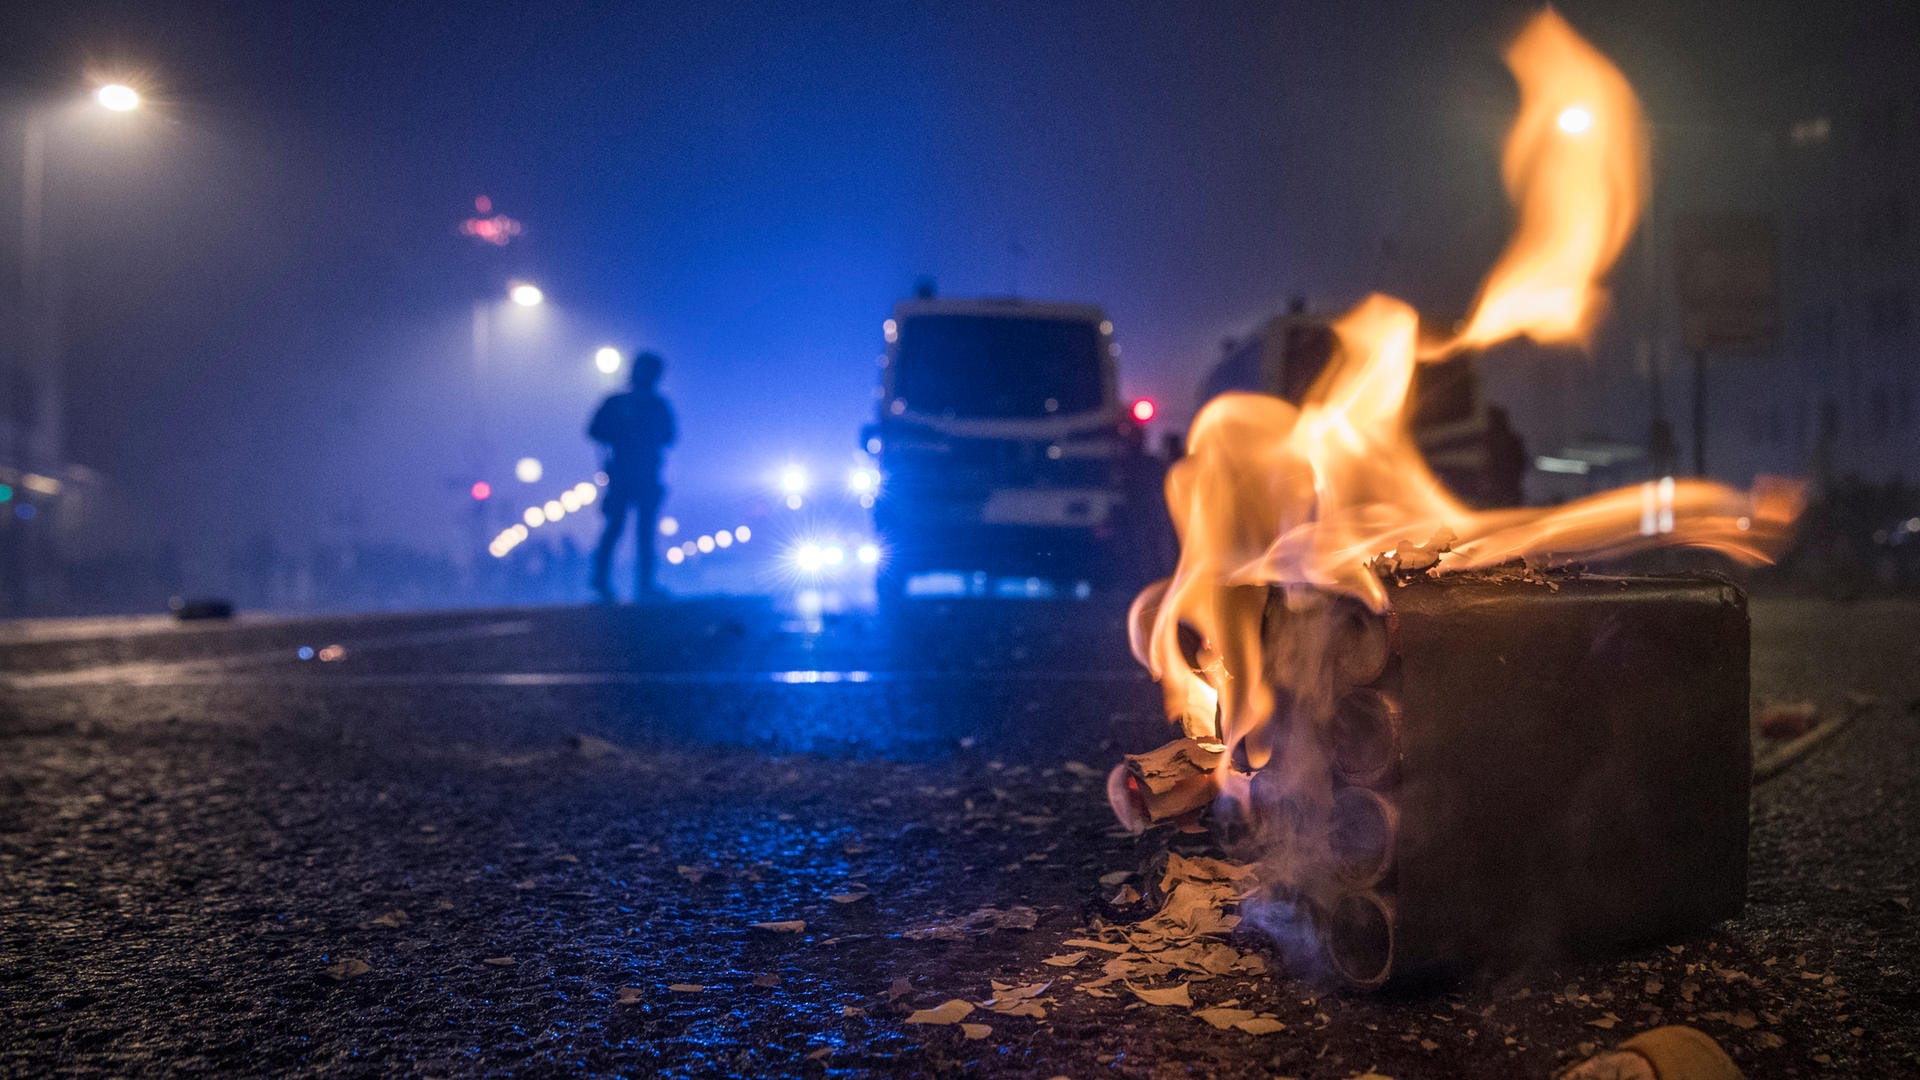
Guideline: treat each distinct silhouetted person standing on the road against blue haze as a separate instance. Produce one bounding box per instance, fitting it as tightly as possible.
[588,352,674,601]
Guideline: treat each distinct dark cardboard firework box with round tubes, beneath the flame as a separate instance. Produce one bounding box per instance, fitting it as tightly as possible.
[1252,573,1751,988]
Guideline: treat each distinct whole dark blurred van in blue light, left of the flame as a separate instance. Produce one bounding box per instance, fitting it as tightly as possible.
[862,298,1158,600]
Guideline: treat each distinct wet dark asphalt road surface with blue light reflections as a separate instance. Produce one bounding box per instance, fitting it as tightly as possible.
[0,601,1920,1080]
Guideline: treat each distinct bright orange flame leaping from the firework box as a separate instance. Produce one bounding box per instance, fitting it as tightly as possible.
[1131,12,1797,753]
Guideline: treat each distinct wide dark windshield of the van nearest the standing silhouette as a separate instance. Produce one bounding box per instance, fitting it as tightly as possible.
[893,315,1102,417]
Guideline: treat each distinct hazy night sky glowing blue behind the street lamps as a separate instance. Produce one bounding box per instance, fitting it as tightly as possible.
[0,0,1904,576]
